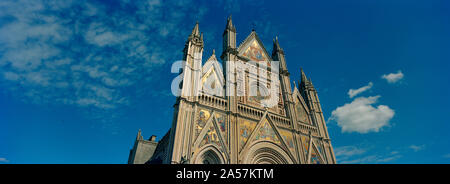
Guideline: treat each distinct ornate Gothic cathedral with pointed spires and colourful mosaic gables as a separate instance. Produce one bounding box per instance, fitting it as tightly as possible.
[128,17,336,164]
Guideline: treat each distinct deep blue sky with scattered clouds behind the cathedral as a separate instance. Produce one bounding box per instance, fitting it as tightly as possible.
[0,0,450,163]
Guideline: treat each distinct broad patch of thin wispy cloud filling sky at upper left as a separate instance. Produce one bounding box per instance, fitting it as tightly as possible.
[0,0,208,109]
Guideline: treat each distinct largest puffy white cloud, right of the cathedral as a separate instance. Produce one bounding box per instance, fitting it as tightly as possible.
[330,96,394,134]
